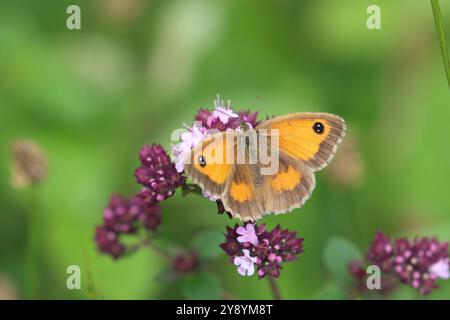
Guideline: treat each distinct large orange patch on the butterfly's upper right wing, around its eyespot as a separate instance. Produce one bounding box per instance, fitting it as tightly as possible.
[271,119,330,161]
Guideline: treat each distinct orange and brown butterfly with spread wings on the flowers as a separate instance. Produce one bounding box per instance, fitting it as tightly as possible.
[185,113,346,221]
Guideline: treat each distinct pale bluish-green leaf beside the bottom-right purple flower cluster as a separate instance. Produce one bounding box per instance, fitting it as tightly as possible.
[324,238,363,286]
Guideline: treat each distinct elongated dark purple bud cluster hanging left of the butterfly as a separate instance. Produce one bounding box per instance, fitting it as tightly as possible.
[95,144,184,259]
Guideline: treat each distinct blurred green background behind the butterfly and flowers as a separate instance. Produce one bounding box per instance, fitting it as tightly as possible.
[0,0,450,299]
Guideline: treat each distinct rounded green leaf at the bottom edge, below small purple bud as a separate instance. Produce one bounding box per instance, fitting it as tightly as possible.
[183,272,220,300]
